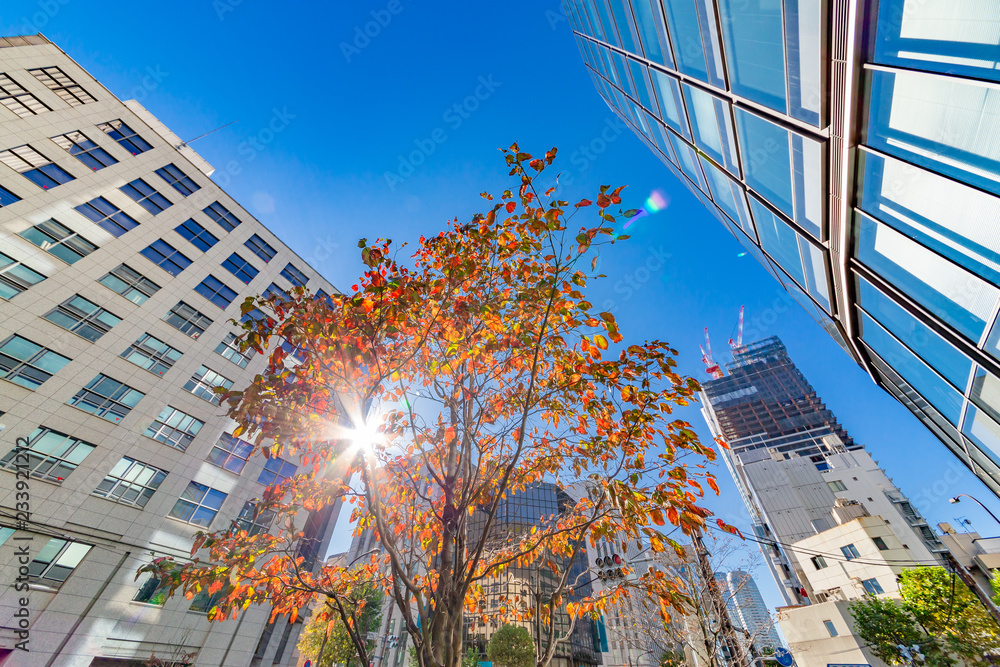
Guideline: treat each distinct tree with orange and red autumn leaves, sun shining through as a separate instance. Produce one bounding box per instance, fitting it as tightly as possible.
[139,144,718,667]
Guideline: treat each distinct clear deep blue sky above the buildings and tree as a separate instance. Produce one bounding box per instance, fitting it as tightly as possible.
[0,0,1000,606]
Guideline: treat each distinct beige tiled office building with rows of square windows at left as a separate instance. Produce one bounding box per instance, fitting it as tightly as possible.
[0,35,339,667]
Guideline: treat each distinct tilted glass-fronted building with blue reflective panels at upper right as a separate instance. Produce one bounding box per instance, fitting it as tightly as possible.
[564,0,1000,500]
